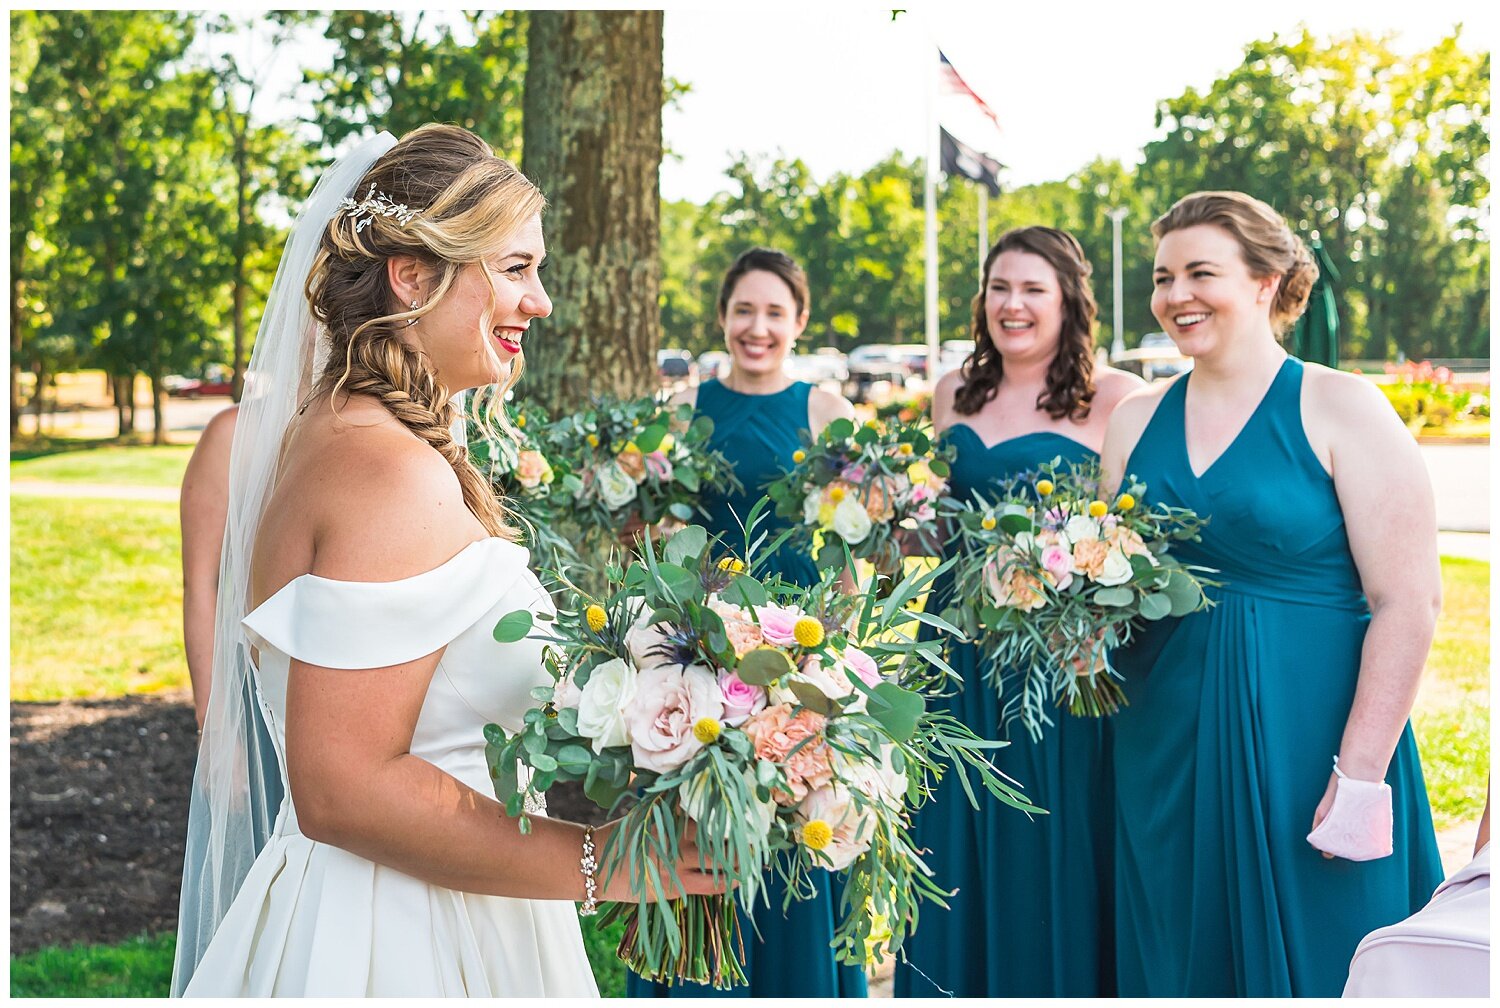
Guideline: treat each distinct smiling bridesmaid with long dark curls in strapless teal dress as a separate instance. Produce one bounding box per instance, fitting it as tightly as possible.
[894,227,1143,998]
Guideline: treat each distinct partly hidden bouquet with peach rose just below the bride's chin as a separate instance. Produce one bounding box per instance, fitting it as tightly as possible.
[467,389,575,569]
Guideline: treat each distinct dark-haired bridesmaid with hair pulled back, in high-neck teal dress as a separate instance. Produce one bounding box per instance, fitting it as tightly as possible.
[627,248,866,998]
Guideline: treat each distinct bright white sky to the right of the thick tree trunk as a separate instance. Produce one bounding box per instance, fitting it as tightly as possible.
[662,0,1497,203]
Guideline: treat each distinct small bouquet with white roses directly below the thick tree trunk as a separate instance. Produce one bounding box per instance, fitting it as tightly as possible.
[549,398,740,537]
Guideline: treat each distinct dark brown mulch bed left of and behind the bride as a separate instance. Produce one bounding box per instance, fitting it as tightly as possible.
[11,693,600,954]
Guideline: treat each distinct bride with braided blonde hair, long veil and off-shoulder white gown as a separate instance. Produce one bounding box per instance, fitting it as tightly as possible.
[173,125,720,996]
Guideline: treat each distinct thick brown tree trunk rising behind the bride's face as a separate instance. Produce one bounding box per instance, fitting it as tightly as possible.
[522,11,663,413]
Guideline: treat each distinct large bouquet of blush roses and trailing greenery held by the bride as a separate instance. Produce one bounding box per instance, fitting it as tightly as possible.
[485,516,1040,987]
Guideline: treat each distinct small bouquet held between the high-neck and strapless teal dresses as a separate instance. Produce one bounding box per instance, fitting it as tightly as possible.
[768,419,957,575]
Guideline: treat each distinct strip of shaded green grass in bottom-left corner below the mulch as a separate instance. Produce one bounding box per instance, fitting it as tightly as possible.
[11,932,177,998]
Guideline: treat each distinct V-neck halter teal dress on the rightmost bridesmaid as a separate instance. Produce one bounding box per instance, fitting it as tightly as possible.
[1112,357,1443,998]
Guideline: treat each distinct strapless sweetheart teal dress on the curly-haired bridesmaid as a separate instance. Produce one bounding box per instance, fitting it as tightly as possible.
[894,423,1115,998]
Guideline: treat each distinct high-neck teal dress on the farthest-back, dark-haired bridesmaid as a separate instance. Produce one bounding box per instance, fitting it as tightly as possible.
[626,378,867,998]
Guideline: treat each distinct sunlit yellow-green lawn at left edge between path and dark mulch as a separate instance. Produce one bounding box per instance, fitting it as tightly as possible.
[11,497,188,701]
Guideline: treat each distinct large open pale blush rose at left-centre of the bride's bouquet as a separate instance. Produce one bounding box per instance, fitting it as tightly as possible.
[626,665,725,774]
